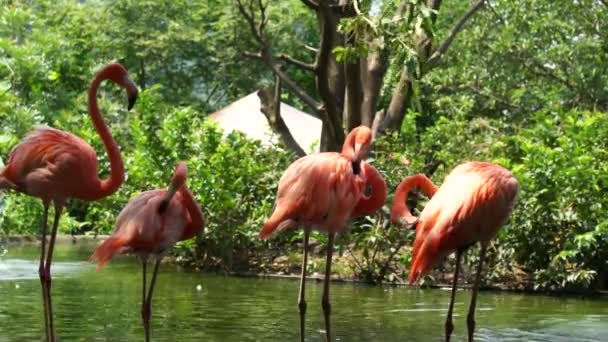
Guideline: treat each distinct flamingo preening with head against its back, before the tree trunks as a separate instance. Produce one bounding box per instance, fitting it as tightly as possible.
[260,126,387,341]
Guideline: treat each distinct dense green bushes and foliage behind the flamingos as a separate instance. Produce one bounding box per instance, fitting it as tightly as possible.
[0,0,608,289]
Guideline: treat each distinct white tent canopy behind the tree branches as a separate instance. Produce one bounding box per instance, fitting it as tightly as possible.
[209,92,321,153]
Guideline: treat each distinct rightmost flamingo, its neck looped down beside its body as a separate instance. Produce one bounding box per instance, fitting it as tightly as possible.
[391,162,519,342]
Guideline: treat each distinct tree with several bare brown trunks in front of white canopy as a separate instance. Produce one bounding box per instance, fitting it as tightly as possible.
[235,0,485,155]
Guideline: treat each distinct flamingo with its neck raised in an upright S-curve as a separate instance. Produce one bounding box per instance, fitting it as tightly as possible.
[0,63,137,342]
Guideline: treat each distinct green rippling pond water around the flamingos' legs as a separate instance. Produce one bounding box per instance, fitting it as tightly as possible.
[0,243,608,342]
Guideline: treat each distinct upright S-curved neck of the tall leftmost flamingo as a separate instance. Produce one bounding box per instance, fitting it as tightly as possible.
[89,72,125,198]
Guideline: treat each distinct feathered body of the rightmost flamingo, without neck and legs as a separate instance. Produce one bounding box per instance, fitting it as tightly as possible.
[410,162,518,283]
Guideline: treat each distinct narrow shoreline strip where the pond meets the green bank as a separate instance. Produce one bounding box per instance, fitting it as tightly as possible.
[0,234,608,298]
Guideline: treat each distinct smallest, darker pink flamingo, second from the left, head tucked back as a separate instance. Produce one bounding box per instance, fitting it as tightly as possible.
[91,162,204,342]
